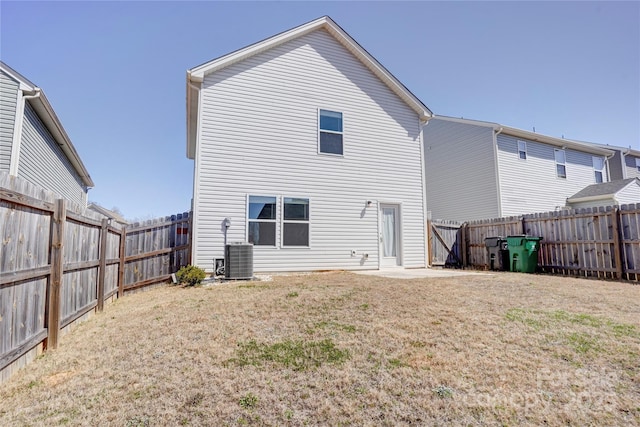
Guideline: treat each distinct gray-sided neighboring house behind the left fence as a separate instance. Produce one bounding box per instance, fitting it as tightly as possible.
[0,62,94,209]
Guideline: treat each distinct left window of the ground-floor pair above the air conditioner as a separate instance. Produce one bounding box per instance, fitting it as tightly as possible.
[247,196,276,246]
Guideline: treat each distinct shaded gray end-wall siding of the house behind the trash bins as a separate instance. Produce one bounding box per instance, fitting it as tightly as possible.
[424,119,500,221]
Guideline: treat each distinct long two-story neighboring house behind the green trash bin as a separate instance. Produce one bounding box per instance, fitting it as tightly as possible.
[423,116,613,221]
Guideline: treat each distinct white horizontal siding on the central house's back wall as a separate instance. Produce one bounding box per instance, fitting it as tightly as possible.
[194,30,426,271]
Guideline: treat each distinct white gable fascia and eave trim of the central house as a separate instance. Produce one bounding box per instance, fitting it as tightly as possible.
[187,16,433,121]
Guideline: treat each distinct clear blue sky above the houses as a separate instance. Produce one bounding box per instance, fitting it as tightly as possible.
[0,0,640,219]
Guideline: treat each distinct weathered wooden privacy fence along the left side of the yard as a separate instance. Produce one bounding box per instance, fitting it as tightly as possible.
[0,181,191,382]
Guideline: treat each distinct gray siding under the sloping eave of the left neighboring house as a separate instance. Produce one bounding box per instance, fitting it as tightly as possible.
[18,102,87,207]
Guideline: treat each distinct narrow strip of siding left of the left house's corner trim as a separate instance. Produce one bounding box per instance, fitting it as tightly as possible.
[0,71,19,172]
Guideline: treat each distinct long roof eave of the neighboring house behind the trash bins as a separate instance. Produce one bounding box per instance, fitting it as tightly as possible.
[433,116,614,156]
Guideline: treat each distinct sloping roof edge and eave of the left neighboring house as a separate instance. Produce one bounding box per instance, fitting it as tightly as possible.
[0,61,95,187]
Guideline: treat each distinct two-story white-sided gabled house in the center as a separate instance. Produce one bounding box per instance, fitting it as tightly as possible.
[187,17,431,271]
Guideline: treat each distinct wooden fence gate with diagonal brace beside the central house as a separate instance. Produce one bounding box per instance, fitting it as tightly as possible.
[428,219,462,267]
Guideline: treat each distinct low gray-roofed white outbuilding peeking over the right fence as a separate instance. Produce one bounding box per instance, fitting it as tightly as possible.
[567,178,640,209]
